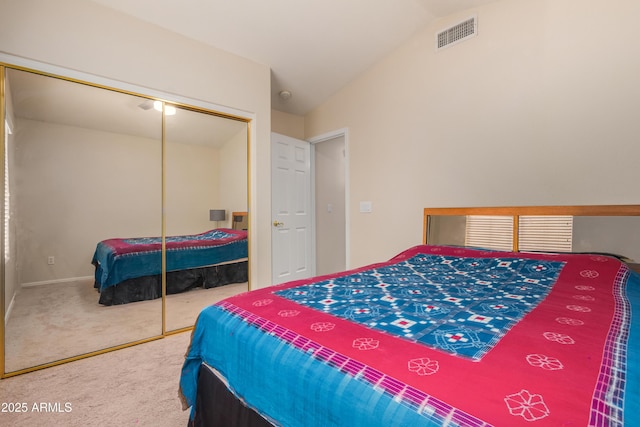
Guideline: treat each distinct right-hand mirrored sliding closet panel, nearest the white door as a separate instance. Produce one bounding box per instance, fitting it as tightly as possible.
[165,106,248,331]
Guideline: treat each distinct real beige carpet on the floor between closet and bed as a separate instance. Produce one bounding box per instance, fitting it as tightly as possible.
[0,333,190,427]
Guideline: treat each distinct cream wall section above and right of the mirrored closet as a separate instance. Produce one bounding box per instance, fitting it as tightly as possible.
[0,0,271,287]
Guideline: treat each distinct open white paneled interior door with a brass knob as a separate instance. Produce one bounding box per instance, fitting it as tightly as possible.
[271,133,313,285]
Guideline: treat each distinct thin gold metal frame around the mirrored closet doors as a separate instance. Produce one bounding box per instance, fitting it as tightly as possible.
[0,62,251,378]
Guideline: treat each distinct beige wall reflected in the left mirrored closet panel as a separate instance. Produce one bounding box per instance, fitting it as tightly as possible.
[15,119,162,284]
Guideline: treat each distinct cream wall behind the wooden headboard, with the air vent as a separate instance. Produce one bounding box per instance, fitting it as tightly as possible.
[305,0,640,267]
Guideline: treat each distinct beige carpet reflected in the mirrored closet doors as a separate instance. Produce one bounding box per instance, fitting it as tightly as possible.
[5,279,247,372]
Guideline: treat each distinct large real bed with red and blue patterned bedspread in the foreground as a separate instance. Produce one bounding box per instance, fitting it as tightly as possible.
[180,206,640,427]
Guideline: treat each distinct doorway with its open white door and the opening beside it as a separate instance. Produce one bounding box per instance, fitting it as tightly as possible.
[271,129,349,285]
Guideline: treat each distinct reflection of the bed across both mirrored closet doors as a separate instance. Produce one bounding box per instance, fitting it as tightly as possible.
[92,212,248,306]
